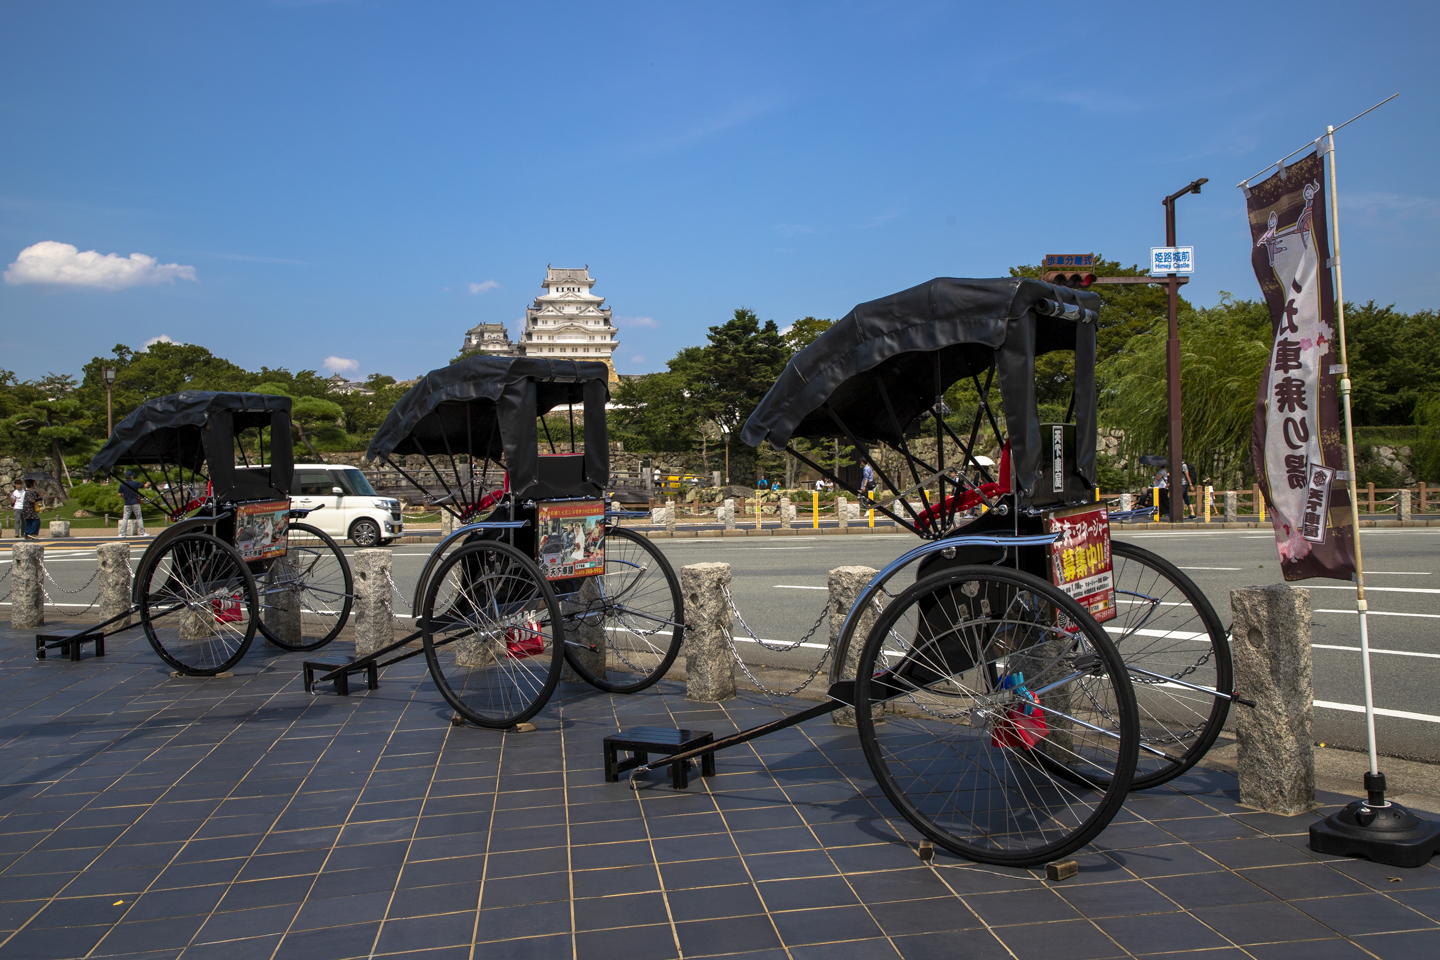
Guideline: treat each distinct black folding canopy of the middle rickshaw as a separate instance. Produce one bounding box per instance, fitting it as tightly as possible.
[366,354,611,498]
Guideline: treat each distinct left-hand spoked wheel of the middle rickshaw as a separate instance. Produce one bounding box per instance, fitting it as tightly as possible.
[420,541,564,728]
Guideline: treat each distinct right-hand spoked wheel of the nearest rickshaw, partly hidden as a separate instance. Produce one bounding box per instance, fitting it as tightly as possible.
[1104,541,1234,790]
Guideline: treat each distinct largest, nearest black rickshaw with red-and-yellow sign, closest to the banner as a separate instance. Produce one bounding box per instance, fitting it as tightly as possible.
[632,278,1238,866]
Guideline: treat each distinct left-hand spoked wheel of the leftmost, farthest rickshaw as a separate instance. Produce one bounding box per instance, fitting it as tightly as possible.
[140,533,259,676]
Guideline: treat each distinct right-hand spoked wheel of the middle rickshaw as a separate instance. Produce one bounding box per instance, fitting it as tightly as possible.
[560,527,685,694]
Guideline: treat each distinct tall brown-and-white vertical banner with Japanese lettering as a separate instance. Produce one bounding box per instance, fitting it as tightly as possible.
[1246,154,1355,580]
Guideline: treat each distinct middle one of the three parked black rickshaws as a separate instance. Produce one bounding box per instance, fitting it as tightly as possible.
[305,356,685,730]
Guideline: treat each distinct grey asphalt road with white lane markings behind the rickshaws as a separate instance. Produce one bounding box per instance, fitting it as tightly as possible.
[19,528,1440,763]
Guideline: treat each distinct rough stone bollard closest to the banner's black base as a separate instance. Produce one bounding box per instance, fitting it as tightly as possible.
[1230,583,1315,816]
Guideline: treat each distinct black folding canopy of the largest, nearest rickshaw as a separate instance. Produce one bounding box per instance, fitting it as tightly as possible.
[740,276,1100,495]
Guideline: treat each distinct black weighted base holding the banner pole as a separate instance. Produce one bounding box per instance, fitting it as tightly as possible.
[1310,773,1440,866]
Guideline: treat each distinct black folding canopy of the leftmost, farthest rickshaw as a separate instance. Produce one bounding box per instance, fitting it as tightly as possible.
[88,390,295,502]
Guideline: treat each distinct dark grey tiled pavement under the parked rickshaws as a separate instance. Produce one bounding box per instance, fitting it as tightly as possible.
[0,626,1440,960]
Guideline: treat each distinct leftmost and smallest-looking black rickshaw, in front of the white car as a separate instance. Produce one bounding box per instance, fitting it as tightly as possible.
[62,390,354,676]
